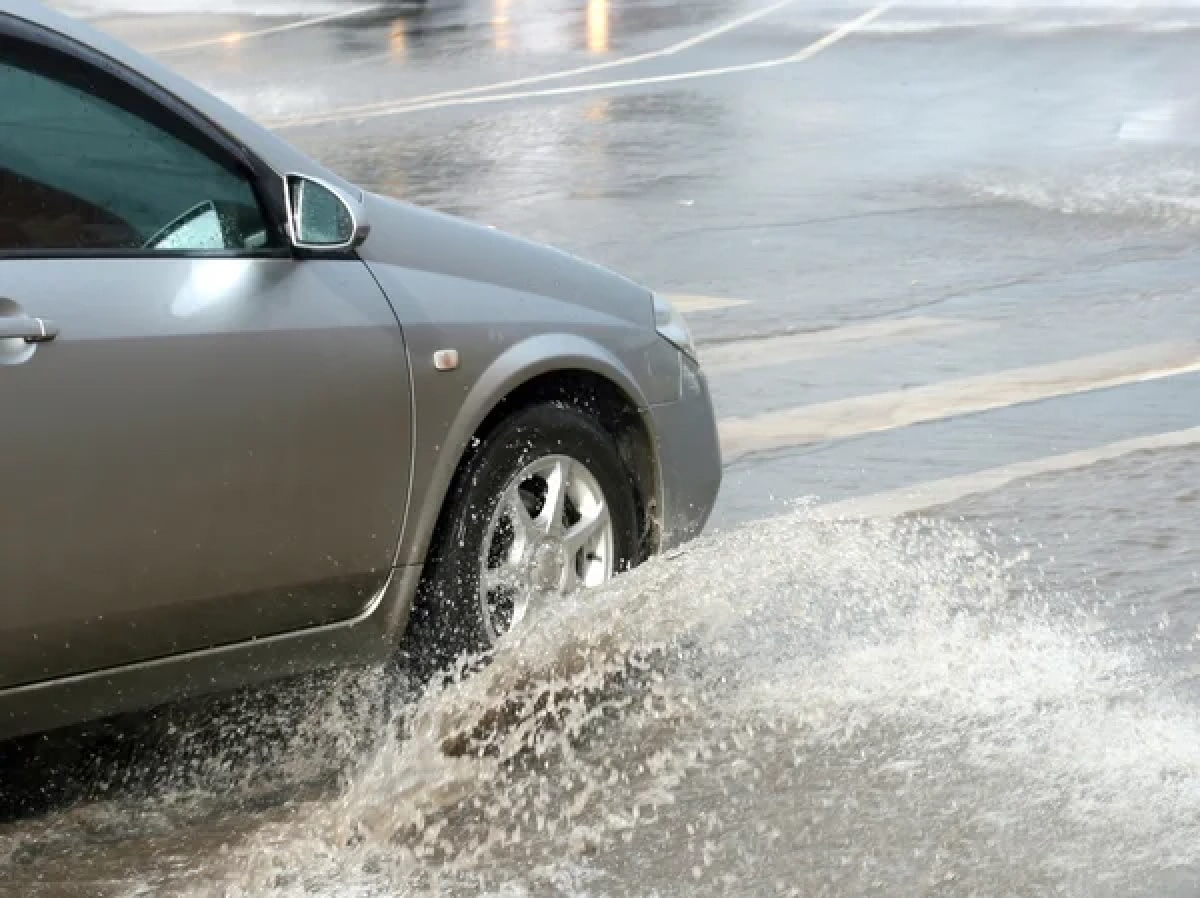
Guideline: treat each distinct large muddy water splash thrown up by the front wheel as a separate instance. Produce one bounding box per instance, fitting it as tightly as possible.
[2,513,1200,898]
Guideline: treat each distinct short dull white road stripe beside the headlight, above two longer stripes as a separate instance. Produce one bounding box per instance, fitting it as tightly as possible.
[701,316,995,372]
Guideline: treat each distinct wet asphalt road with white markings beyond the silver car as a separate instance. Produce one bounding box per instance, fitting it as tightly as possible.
[7,0,1200,894]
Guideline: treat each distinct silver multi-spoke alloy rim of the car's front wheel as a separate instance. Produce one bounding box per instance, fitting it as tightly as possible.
[479,455,613,643]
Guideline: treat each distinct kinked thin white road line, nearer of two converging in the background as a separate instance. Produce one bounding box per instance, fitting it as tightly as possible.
[272,0,894,130]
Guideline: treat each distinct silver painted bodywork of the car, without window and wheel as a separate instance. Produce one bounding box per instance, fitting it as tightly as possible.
[0,0,721,737]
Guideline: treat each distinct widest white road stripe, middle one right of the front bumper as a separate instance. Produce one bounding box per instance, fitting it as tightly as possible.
[720,342,1200,462]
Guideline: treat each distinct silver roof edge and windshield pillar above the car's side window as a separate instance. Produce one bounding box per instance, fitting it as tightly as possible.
[0,0,360,193]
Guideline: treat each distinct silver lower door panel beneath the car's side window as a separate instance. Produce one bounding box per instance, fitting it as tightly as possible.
[0,258,412,686]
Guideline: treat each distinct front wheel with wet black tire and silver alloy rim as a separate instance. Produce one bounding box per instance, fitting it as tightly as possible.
[406,401,638,678]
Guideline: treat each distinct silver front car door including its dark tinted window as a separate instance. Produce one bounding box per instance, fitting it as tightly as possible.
[0,26,412,688]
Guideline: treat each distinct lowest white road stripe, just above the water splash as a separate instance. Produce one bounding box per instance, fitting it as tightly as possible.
[812,427,1200,520]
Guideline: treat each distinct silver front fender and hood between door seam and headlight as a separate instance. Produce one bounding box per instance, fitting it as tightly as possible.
[359,193,680,564]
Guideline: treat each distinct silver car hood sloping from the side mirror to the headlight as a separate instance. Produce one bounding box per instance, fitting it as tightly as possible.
[359,193,654,327]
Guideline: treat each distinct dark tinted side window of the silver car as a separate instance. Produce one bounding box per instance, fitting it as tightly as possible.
[0,61,274,253]
